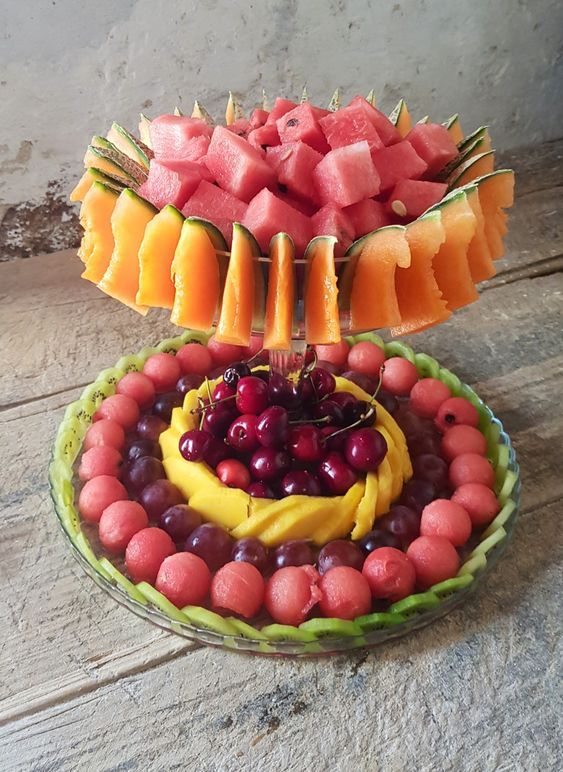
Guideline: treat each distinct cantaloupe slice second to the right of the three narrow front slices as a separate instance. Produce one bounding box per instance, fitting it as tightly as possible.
[391,210,451,335]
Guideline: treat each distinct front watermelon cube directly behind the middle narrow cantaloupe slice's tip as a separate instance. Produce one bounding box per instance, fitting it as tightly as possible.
[242,188,311,255]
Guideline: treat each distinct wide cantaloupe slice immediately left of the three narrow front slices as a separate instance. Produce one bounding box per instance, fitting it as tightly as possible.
[172,217,220,330]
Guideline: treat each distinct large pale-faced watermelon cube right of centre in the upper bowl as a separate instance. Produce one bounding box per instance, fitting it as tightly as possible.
[313,140,379,208]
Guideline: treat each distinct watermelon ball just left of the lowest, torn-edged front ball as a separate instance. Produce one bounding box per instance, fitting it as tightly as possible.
[211,560,264,619]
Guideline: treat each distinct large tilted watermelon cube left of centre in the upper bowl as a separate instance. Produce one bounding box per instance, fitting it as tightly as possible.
[205,126,276,201]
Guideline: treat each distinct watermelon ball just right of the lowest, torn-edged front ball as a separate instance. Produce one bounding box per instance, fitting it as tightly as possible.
[319,566,371,619]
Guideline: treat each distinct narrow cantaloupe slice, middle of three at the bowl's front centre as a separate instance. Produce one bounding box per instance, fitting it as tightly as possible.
[264,233,295,351]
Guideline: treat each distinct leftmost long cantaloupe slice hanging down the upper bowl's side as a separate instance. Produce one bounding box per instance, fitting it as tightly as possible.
[78,182,119,283]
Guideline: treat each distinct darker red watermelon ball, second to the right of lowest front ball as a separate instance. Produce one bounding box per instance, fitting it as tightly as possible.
[362,547,416,603]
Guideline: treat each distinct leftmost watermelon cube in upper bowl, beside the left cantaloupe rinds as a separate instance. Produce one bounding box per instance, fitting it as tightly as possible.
[139,158,209,209]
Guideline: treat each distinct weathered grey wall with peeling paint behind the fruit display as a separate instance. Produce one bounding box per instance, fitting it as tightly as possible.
[0,0,563,256]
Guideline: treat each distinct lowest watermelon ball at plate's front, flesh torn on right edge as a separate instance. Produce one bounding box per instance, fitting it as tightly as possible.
[264,566,322,625]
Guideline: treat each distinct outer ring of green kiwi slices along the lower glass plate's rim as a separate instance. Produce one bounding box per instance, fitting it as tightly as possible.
[49,331,520,656]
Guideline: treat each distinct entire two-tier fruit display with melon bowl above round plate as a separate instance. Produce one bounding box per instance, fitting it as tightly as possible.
[50,92,520,655]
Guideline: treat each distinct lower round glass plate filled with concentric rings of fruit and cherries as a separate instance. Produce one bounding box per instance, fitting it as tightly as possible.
[50,331,520,655]
